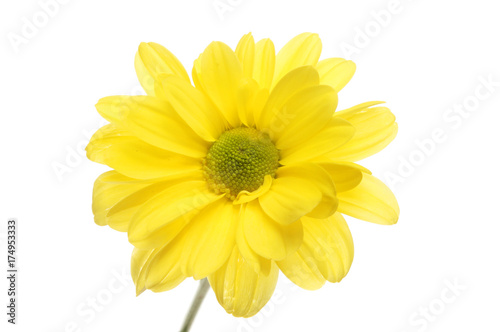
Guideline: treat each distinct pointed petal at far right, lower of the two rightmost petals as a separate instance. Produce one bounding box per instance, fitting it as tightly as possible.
[337,173,399,225]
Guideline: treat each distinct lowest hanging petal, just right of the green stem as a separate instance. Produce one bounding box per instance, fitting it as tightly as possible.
[208,247,278,317]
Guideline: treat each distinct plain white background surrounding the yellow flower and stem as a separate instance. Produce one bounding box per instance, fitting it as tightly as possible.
[0,0,500,332]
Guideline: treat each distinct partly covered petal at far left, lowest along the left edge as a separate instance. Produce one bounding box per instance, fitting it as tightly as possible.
[92,171,152,232]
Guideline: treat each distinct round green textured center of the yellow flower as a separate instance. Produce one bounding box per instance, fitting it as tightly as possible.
[203,127,279,200]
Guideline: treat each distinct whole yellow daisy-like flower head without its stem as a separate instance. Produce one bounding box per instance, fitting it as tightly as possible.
[87,33,399,317]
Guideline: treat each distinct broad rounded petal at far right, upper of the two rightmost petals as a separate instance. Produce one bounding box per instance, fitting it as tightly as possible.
[328,102,398,161]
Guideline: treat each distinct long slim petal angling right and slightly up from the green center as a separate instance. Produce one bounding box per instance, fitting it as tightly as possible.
[280,118,355,165]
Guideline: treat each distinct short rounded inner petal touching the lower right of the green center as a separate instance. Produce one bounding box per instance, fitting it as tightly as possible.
[259,176,323,225]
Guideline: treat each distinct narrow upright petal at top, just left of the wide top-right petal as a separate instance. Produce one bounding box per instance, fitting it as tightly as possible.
[253,38,276,90]
